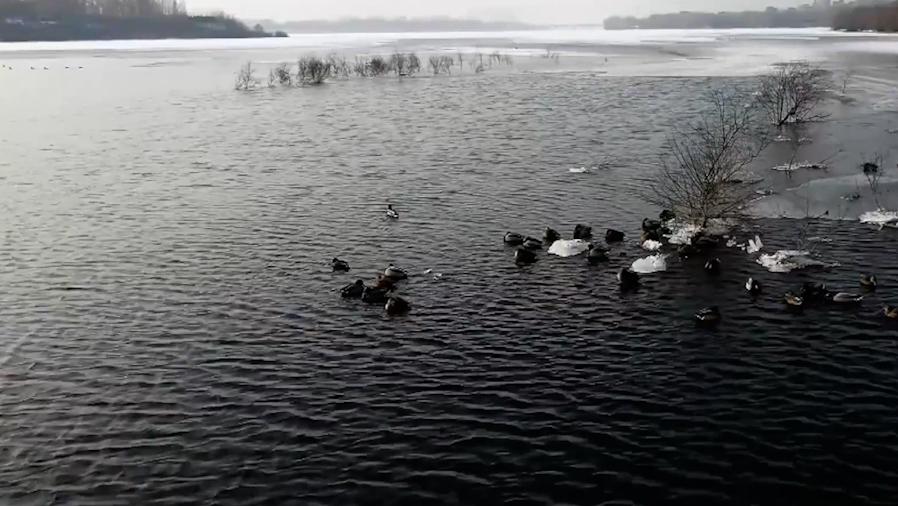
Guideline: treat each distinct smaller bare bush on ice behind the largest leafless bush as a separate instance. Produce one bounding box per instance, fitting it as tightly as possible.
[757,61,830,127]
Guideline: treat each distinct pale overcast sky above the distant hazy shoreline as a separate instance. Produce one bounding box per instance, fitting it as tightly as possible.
[186,0,811,23]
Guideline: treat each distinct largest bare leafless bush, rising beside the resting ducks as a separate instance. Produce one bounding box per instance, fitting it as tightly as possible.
[647,91,769,227]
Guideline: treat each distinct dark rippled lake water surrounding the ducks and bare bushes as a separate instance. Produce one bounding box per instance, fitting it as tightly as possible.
[0,30,898,505]
